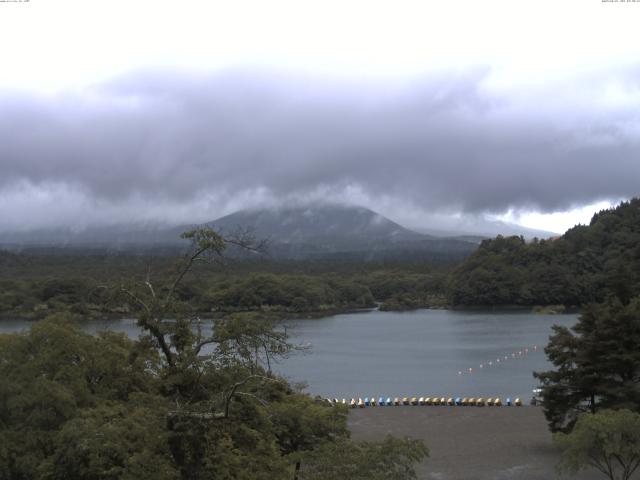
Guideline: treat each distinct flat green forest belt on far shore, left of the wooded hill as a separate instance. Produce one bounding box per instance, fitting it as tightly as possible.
[0,254,447,319]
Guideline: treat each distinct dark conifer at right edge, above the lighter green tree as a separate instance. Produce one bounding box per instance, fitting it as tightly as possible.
[534,297,640,431]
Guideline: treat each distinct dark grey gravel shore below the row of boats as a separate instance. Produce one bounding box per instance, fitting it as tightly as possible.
[349,406,604,480]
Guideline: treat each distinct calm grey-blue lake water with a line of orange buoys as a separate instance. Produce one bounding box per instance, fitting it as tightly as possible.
[0,310,577,401]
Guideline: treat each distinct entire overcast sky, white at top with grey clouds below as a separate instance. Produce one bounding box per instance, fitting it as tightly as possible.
[0,0,640,236]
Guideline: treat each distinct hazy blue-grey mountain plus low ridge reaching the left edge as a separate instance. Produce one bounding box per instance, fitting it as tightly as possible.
[0,204,477,262]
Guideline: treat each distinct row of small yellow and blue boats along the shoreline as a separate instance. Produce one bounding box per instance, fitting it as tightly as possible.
[326,397,522,408]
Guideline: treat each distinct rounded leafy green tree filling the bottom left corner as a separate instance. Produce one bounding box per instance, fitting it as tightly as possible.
[0,314,165,480]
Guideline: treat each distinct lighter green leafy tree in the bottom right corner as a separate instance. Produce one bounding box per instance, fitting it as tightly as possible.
[553,410,640,480]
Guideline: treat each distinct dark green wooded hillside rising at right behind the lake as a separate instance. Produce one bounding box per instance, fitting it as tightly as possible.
[448,198,640,305]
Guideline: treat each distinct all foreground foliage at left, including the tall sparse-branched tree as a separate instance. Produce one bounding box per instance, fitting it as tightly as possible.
[0,231,424,480]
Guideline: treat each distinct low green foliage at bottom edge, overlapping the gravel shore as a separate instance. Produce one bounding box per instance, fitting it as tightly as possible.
[299,436,429,480]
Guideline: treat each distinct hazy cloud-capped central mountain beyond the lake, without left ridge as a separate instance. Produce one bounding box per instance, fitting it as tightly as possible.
[199,205,476,261]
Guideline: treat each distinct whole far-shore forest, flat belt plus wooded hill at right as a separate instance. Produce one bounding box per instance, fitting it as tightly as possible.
[7,199,640,319]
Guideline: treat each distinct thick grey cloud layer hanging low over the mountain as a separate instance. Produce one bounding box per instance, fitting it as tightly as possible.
[0,68,640,229]
